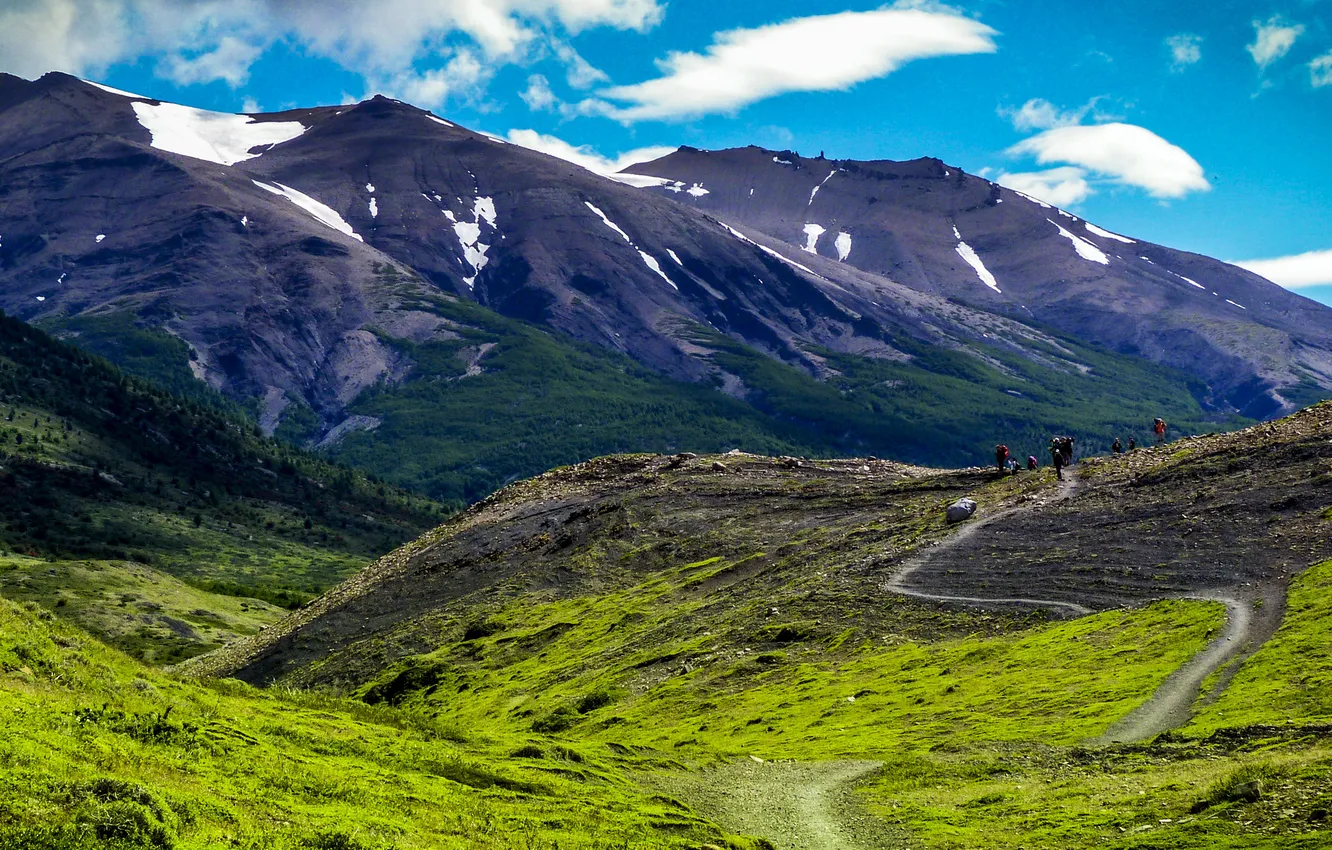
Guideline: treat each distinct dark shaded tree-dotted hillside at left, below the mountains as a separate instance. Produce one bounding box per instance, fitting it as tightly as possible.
[0,309,442,658]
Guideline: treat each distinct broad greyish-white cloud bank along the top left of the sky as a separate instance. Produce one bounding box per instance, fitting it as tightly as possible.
[0,0,665,104]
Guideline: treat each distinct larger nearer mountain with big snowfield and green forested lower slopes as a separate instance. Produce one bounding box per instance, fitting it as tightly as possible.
[0,73,1328,504]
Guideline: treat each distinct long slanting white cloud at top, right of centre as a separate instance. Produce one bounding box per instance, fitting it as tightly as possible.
[602,8,998,121]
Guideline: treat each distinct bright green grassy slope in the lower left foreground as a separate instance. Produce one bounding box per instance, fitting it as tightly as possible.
[0,601,772,850]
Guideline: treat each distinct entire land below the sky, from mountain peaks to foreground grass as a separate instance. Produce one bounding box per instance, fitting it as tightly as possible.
[0,72,1332,850]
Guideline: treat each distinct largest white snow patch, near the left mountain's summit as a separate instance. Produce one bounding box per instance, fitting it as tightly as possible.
[133,103,306,165]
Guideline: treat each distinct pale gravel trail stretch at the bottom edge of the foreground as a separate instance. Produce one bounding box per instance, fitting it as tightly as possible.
[649,761,904,850]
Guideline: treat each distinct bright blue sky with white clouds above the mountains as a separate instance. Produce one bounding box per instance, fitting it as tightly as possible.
[0,0,1332,304]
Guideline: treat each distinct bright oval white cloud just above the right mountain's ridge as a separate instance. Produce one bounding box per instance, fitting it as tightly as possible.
[1008,123,1212,197]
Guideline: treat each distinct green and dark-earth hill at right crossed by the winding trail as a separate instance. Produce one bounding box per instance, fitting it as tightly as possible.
[174,405,1332,850]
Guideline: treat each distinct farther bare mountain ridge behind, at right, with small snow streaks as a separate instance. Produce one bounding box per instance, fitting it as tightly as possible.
[625,147,1332,418]
